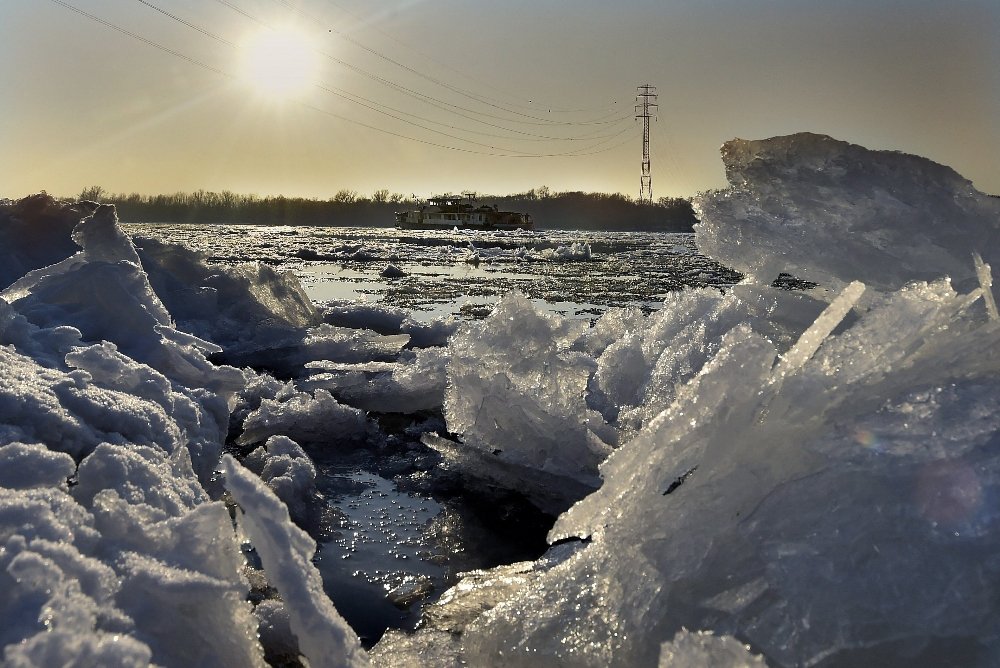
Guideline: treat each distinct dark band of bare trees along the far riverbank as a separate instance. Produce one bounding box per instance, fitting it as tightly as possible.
[79,186,697,232]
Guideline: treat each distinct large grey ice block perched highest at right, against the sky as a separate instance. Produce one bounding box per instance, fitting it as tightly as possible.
[695,133,1000,290]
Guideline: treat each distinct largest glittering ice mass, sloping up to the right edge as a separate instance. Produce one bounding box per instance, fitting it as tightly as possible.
[462,274,1000,666]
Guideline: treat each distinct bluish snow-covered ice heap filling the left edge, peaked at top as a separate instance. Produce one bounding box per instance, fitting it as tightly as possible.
[0,196,364,667]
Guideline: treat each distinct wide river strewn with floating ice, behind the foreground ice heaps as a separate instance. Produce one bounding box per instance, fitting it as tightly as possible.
[125,224,739,321]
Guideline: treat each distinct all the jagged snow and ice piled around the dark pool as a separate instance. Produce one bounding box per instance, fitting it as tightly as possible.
[0,134,1000,666]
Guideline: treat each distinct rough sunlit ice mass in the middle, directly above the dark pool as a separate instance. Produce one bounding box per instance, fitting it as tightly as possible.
[438,284,826,508]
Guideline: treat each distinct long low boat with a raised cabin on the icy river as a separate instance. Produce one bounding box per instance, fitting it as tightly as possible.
[396,193,535,230]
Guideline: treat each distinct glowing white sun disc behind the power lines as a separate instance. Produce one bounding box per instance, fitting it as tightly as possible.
[240,28,319,99]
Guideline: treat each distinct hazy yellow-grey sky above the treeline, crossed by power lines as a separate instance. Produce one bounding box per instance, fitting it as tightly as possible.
[0,0,1000,198]
